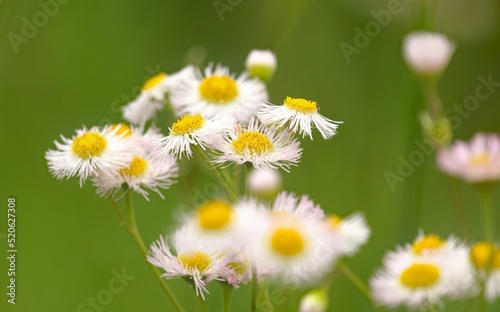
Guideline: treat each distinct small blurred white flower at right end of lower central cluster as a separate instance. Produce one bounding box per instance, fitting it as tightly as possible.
[325,213,370,257]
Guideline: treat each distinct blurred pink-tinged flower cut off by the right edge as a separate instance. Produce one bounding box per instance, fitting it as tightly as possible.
[437,133,500,183]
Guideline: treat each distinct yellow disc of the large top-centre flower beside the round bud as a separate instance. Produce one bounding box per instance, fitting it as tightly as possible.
[199,75,238,104]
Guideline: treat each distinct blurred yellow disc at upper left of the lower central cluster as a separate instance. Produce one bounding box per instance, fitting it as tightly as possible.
[198,200,233,230]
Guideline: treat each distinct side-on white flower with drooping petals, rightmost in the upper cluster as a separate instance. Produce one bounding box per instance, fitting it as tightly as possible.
[257,97,343,140]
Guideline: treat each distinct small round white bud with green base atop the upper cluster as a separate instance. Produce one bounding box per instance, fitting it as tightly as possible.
[245,50,278,81]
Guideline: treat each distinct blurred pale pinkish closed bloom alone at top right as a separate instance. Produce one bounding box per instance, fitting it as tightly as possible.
[403,31,455,75]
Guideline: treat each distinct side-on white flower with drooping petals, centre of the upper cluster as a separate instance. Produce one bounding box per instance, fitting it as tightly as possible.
[158,113,235,158]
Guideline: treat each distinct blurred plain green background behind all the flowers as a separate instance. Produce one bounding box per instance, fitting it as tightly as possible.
[0,0,500,312]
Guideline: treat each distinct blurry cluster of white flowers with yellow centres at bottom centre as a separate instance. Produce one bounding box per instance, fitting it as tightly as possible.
[148,192,370,296]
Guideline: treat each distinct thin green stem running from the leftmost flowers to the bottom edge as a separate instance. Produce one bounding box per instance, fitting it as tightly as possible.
[125,192,184,312]
